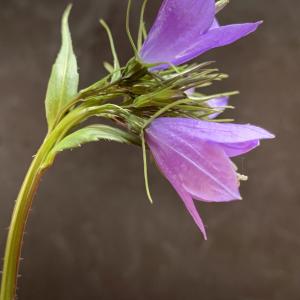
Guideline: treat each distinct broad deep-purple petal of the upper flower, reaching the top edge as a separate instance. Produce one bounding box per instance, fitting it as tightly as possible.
[140,0,215,63]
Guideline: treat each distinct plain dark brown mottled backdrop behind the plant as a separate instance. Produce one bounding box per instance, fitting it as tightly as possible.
[0,0,300,300]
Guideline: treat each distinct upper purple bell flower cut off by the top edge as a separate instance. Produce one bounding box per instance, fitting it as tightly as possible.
[140,0,262,68]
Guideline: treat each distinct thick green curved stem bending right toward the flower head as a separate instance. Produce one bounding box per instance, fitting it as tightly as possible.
[0,104,116,300]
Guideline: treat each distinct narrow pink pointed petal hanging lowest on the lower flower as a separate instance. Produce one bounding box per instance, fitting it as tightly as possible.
[148,139,207,240]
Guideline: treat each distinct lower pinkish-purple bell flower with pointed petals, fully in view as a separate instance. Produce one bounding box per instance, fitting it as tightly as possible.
[146,118,274,239]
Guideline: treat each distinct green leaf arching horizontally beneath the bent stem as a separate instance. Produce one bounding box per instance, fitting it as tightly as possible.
[43,124,141,168]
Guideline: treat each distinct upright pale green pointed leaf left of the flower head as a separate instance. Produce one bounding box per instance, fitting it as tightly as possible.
[46,5,79,130]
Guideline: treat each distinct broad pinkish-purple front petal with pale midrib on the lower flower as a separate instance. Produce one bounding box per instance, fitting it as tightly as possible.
[147,126,240,202]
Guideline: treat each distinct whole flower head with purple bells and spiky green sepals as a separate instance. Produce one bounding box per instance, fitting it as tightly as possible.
[71,0,274,239]
